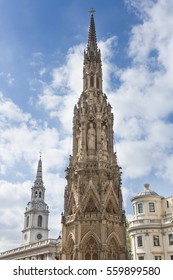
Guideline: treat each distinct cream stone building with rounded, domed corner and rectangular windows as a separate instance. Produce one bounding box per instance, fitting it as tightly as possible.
[129,184,173,260]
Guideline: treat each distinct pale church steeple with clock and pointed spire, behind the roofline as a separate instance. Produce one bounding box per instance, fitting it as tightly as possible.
[22,156,49,245]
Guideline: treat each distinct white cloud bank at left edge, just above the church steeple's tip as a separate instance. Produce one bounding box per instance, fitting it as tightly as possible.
[0,89,71,174]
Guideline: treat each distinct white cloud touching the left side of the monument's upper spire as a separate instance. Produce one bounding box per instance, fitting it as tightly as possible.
[39,45,84,135]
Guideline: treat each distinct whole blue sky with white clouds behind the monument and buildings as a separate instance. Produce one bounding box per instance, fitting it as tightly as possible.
[0,0,173,251]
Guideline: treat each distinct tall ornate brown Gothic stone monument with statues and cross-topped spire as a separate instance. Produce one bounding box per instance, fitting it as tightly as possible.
[62,9,126,260]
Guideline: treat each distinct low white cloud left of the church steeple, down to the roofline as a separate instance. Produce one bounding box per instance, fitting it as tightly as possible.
[0,180,31,251]
